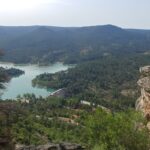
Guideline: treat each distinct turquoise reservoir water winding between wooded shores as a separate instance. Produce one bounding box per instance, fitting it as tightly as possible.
[0,63,70,100]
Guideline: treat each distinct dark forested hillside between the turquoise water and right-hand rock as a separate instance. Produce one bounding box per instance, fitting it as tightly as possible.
[33,54,150,111]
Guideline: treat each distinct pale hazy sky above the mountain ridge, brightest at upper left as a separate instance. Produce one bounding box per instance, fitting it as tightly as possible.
[0,0,150,29]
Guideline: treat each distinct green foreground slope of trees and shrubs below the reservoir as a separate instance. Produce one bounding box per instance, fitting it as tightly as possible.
[0,94,150,150]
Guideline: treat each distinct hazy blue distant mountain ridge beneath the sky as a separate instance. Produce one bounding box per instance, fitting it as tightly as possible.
[0,25,150,63]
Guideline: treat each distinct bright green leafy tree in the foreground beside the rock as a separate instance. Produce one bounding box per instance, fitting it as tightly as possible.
[84,109,150,150]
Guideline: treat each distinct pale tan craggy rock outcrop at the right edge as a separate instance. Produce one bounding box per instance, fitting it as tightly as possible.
[136,66,150,122]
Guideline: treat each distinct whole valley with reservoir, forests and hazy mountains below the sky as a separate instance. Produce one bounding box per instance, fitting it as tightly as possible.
[0,25,150,150]
